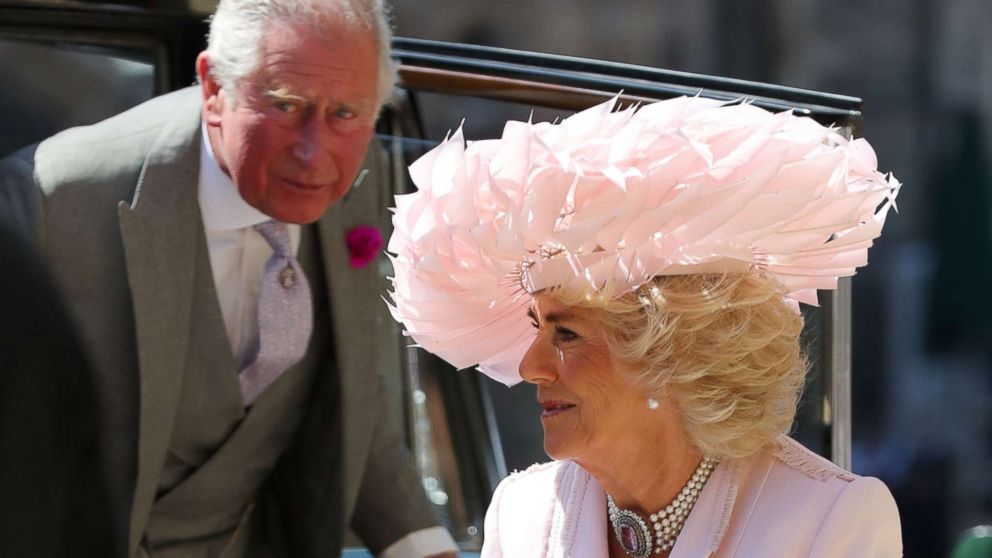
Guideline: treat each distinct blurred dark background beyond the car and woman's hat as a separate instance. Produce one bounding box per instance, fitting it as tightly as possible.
[393,0,992,557]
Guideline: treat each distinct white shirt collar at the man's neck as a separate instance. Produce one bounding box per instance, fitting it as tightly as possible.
[198,124,272,231]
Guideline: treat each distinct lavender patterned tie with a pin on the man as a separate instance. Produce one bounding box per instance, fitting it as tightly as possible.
[239,221,313,407]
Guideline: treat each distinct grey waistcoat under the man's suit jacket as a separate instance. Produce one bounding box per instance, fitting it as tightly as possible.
[140,227,330,558]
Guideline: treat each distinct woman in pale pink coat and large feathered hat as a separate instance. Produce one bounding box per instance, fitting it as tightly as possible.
[390,94,901,558]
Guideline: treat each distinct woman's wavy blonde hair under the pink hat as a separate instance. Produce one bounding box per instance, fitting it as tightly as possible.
[550,271,807,458]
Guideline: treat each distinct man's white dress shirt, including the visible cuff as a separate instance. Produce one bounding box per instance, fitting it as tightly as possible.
[198,126,458,558]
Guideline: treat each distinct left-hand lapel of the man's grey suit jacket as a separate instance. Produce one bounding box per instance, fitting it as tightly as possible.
[118,92,203,556]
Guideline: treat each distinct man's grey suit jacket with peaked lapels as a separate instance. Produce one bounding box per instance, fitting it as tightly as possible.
[0,88,436,558]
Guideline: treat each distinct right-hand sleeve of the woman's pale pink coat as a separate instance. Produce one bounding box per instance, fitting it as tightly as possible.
[810,477,902,558]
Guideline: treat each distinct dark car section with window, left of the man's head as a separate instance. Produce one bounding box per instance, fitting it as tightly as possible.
[0,0,206,157]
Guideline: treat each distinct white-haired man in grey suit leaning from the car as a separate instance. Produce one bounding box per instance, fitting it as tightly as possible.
[0,0,455,558]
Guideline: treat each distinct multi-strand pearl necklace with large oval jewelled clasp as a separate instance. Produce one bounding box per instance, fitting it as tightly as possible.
[606,457,718,558]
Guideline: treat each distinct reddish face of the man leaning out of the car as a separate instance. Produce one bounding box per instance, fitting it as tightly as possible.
[197,19,378,224]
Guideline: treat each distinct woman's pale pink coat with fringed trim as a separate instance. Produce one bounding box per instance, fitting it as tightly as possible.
[482,436,902,558]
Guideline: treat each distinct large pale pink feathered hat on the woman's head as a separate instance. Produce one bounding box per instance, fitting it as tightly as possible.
[387,97,899,384]
